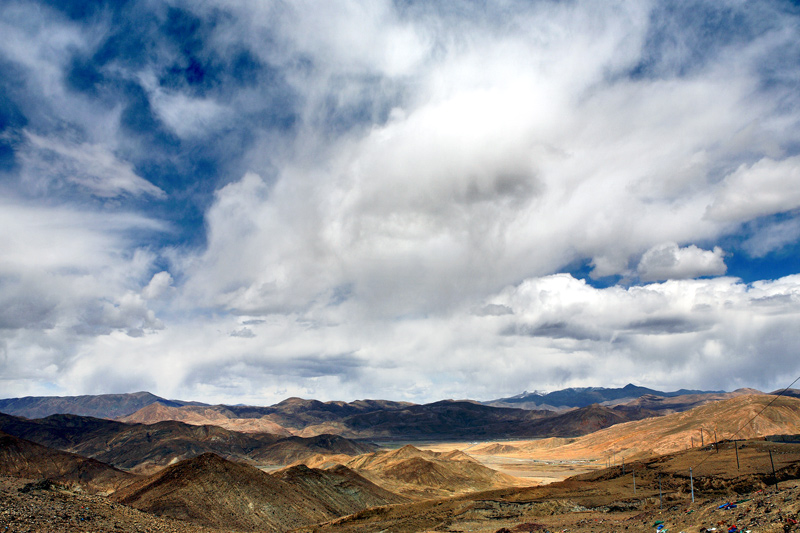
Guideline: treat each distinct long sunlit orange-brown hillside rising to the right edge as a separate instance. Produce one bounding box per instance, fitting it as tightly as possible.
[496,394,800,460]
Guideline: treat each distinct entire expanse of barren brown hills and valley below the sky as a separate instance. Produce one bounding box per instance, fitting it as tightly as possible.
[0,386,800,533]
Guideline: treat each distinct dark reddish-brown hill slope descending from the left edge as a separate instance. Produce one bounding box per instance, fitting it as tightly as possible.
[0,432,136,492]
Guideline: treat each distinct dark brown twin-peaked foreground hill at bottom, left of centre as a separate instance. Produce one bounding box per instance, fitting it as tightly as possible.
[112,453,405,531]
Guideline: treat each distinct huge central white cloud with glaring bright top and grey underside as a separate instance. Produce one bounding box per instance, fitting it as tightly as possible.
[181,1,766,316]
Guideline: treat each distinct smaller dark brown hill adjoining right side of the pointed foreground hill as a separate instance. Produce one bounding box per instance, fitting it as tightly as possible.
[272,465,409,516]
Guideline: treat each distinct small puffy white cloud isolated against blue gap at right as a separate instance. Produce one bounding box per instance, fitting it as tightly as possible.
[637,242,727,281]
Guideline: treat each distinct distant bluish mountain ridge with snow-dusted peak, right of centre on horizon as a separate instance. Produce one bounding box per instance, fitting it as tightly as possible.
[483,383,725,408]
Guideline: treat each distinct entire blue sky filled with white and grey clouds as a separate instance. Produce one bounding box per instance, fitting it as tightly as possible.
[0,0,800,405]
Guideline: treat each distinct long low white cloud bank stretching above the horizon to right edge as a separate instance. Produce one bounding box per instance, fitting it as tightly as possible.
[42,274,800,403]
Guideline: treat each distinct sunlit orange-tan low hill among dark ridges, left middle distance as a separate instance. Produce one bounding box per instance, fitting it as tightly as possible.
[118,402,292,437]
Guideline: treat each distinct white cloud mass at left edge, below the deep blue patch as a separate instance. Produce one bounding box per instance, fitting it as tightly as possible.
[0,202,163,392]
